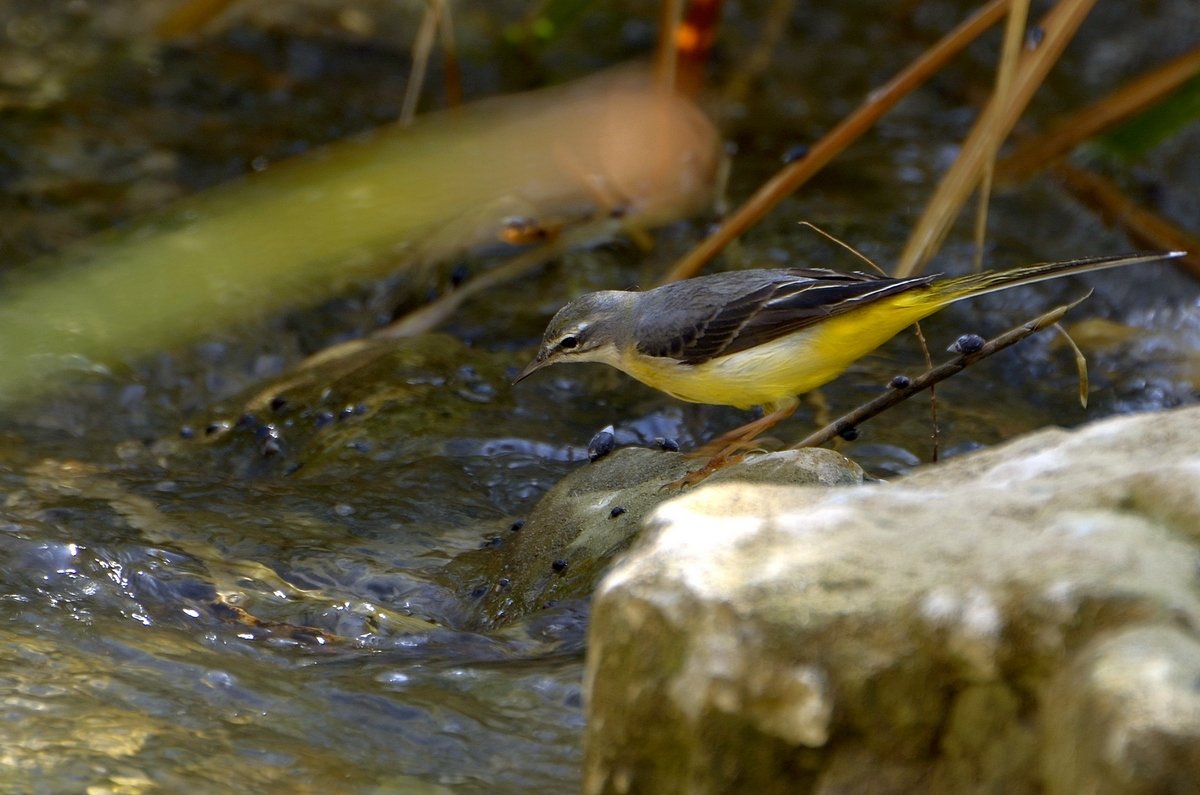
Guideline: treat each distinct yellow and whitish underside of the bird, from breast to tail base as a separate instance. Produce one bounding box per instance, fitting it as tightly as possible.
[619,293,952,408]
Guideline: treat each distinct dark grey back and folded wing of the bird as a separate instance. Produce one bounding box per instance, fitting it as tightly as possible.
[635,268,936,364]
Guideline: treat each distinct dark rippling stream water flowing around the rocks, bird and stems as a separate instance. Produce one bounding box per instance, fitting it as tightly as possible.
[0,0,1200,794]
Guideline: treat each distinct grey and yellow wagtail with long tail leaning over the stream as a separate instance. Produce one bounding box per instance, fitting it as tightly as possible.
[512,251,1183,451]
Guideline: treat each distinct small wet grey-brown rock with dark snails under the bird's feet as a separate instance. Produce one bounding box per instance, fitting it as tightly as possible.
[444,447,863,627]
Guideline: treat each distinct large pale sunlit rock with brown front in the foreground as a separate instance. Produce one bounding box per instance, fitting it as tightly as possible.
[583,408,1200,795]
